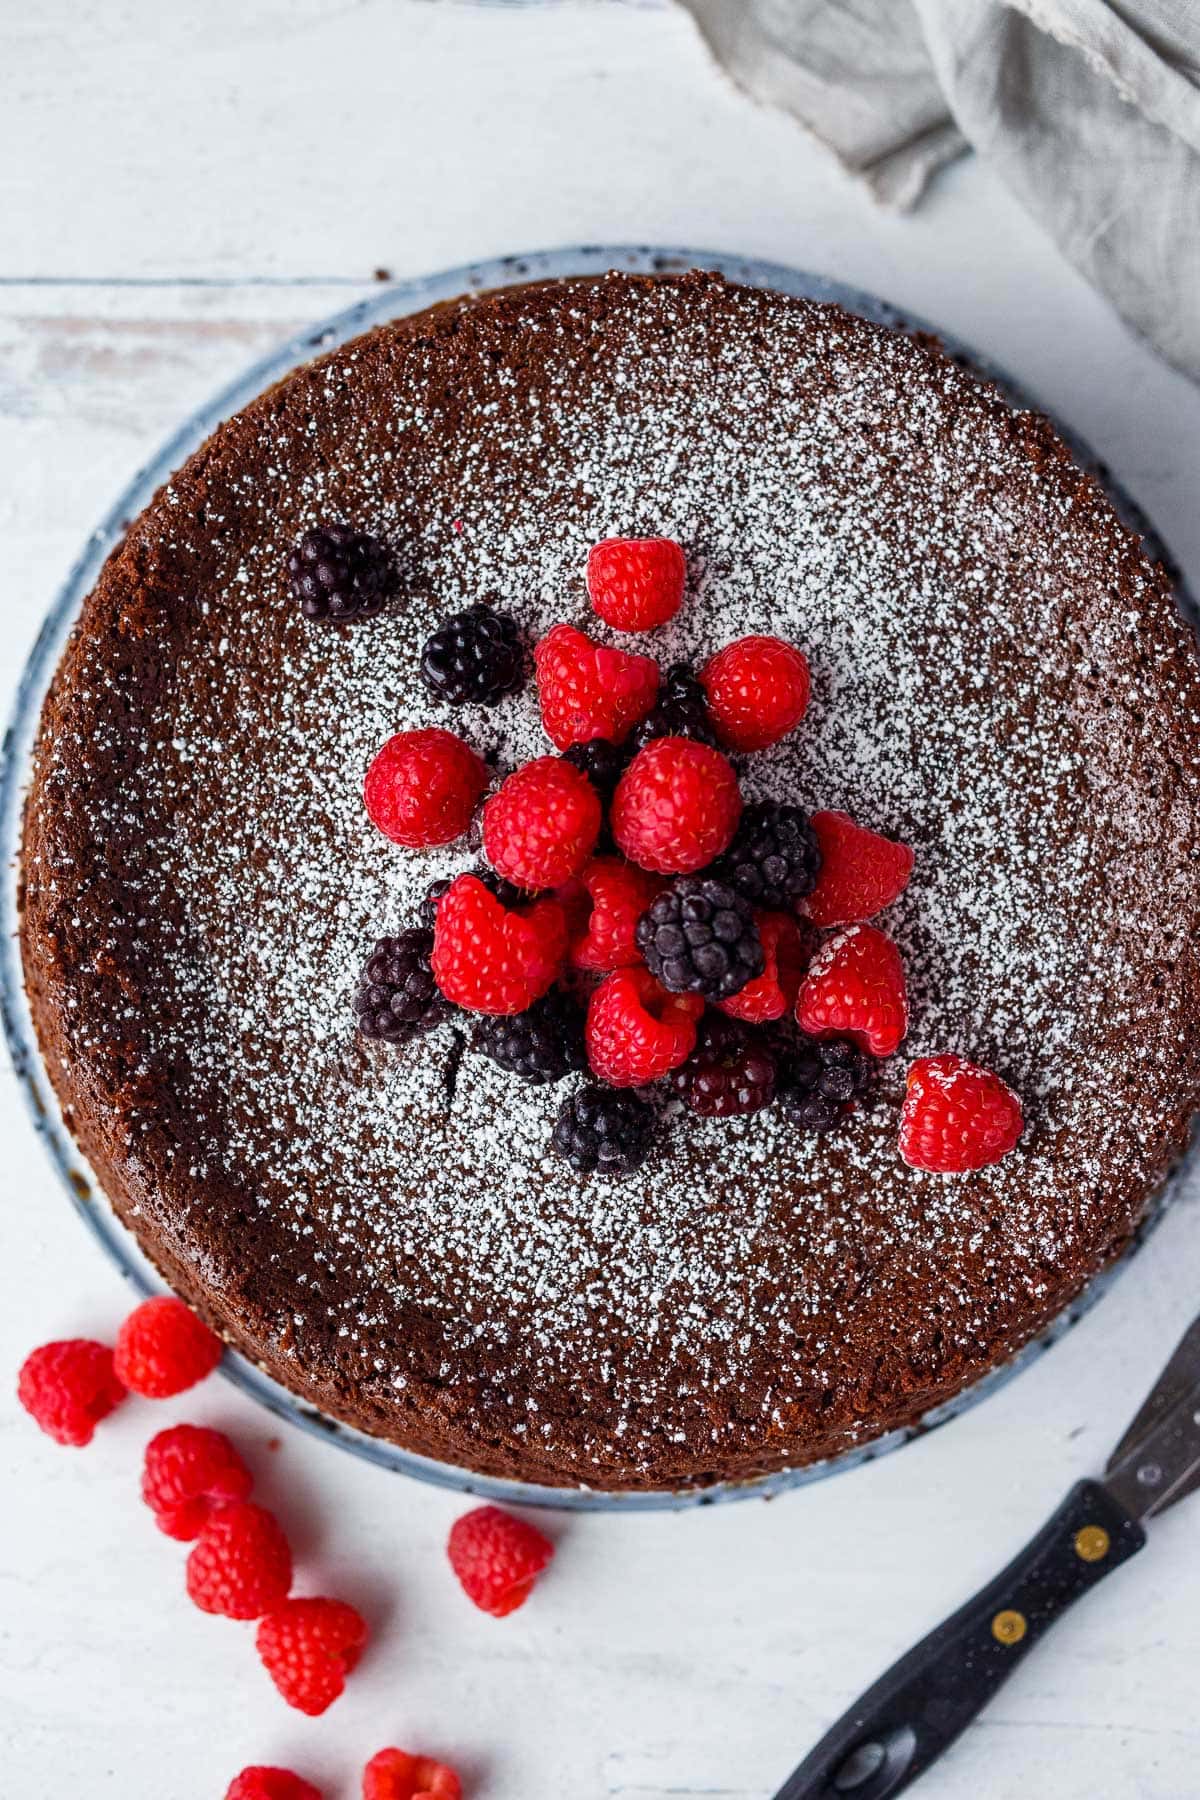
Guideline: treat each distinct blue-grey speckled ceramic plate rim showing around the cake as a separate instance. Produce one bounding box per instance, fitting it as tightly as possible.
[0,245,1195,1512]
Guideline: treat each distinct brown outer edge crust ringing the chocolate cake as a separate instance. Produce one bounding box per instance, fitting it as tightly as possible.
[18,275,1200,1492]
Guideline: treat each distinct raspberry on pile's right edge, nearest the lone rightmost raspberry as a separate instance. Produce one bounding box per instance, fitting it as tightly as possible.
[795,925,909,1057]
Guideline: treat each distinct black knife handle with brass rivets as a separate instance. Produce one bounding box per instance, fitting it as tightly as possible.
[775,1481,1146,1800]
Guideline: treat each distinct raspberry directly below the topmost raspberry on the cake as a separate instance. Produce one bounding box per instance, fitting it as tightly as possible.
[533,625,658,751]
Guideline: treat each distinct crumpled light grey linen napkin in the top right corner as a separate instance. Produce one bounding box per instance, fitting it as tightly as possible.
[680,0,1200,380]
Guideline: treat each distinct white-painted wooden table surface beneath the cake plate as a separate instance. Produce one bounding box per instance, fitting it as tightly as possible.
[0,0,1200,1800]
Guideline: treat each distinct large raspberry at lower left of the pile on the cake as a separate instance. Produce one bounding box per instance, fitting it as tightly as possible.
[434,875,567,1013]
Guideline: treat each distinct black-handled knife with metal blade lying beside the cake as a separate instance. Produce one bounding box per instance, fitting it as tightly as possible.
[775,1318,1200,1800]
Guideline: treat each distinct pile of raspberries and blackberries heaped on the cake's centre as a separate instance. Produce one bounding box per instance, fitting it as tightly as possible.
[344,538,1020,1175]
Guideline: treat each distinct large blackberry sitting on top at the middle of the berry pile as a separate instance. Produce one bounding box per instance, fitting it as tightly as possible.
[637,875,765,1001]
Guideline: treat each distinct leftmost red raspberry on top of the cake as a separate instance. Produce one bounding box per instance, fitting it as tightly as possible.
[363,725,488,850]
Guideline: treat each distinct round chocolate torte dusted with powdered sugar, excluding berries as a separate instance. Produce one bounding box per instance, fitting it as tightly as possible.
[22,275,1200,1489]
